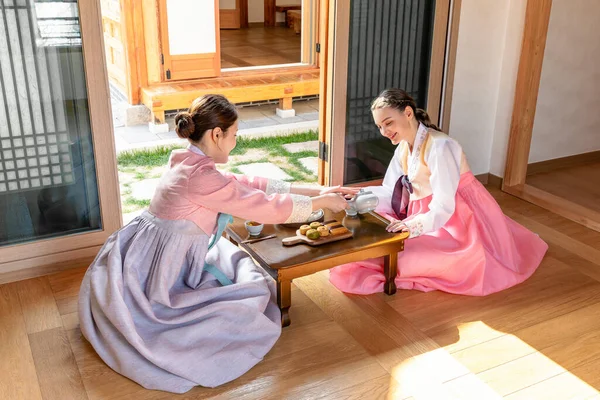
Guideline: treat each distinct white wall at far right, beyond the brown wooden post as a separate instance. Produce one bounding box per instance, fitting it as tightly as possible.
[529,0,600,162]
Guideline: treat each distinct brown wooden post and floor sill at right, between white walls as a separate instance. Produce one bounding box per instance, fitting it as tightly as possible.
[502,0,600,231]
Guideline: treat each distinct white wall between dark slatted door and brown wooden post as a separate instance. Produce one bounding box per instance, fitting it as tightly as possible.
[449,0,526,176]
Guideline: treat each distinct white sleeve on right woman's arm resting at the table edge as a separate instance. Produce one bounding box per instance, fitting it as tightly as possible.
[403,140,462,238]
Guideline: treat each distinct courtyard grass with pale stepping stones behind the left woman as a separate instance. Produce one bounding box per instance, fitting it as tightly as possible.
[117,131,318,217]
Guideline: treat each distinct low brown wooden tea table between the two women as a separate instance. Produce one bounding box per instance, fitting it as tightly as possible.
[225,210,409,327]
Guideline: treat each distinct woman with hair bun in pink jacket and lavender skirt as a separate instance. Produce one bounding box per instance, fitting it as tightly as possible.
[79,95,356,393]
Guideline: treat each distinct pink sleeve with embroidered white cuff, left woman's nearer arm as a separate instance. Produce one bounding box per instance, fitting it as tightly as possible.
[188,168,312,224]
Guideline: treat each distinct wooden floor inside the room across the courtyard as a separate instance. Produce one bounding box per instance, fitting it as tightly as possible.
[221,25,301,68]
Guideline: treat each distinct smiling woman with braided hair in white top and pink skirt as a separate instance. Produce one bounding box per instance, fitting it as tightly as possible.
[330,89,548,296]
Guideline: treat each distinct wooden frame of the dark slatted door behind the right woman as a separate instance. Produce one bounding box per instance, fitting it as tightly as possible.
[318,0,462,186]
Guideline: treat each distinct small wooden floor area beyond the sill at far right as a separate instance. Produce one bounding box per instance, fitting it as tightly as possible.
[527,163,600,212]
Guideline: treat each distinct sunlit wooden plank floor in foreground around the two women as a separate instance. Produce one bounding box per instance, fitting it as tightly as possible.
[0,189,600,400]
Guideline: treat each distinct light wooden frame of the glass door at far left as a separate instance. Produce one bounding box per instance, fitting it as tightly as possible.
[0,0,121,284]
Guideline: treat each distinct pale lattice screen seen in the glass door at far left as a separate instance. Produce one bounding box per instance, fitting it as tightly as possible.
[0,1,74,194]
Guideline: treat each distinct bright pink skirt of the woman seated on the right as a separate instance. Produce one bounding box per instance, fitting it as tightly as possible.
[330,172,548,296]
